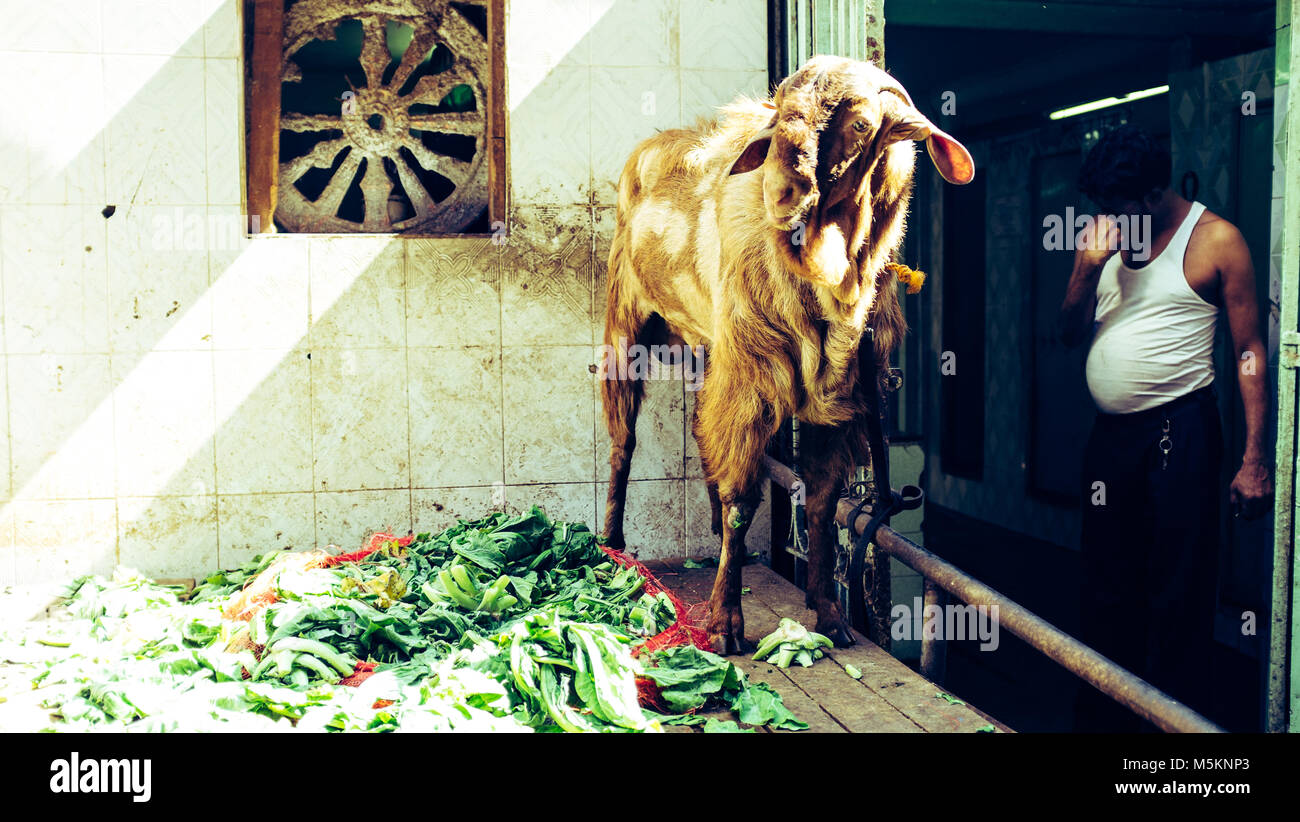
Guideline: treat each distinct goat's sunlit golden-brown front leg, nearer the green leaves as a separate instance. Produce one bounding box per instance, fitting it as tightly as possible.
[696,380,776,654]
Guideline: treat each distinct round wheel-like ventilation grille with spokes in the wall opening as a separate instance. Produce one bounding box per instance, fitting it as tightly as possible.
[276,0,490,233]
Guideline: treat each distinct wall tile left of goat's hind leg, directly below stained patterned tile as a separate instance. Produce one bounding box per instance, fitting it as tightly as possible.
[503,346,595,484]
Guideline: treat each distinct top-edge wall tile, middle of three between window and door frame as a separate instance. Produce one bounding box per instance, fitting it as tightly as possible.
[588,0,690,66]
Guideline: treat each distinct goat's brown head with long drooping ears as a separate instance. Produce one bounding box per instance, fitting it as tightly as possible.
[731,56,975,230]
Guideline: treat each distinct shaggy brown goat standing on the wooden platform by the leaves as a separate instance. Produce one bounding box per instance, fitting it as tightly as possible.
[601,56,974,654]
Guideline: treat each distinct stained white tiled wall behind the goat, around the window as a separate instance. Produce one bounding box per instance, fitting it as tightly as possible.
[0,0,767,584]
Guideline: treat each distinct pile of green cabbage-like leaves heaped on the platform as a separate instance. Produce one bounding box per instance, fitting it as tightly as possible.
[25,507,806,731]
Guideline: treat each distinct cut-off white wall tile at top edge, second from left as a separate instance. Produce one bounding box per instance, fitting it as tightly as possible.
[104,0,212,57]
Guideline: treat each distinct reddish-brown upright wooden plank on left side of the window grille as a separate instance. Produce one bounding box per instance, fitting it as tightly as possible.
[246,0,285,234]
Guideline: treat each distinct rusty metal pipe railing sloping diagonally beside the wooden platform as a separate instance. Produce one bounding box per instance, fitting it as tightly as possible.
[766,457,1223,734]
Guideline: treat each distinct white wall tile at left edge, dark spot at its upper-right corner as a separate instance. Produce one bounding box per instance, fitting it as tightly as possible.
[0,206,108,354]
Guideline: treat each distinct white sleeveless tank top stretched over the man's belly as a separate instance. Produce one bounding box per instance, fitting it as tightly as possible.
[1087,203,1218,414]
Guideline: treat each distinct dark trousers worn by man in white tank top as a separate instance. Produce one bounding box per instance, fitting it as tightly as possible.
[1075,386,1223,732]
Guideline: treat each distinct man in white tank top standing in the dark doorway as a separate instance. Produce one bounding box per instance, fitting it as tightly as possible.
[1060,125,1273,732]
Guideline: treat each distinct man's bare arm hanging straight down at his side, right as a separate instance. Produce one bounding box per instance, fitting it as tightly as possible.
[1214,222,1273,519]
